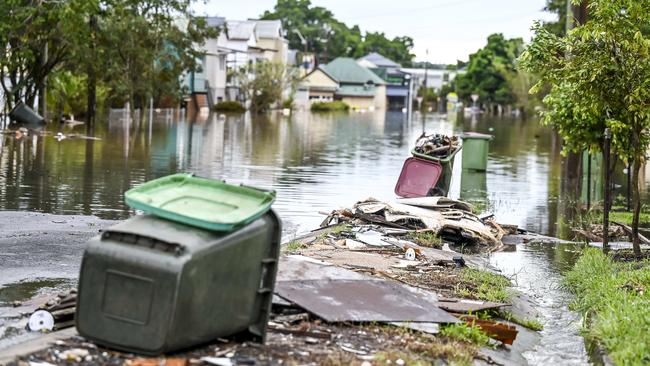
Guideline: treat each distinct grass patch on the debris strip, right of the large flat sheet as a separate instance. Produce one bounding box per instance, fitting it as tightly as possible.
[455,268,510,303]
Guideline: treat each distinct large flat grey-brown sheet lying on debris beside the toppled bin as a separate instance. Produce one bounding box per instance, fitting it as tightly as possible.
[275,280,458,323]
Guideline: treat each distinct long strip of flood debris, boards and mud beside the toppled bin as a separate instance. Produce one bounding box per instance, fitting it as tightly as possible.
[10,197,540,366]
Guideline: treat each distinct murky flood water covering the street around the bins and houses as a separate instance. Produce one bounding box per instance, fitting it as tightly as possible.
[0,110,636,365]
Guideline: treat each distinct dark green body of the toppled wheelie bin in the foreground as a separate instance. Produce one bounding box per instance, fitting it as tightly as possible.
[76,210,281,355]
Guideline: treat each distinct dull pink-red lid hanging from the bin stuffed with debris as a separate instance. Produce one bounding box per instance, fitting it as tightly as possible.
[395,158,442,198]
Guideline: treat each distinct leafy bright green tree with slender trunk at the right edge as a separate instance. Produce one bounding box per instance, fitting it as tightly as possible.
[520,0,650,255]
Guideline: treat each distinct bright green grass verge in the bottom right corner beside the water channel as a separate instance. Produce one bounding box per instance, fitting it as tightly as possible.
[565,248,650,365]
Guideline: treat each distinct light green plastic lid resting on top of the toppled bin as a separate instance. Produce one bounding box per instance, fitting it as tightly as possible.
[124,173,275,231]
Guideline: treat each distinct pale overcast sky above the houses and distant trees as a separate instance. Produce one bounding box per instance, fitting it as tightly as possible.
[193,0,554,64]
